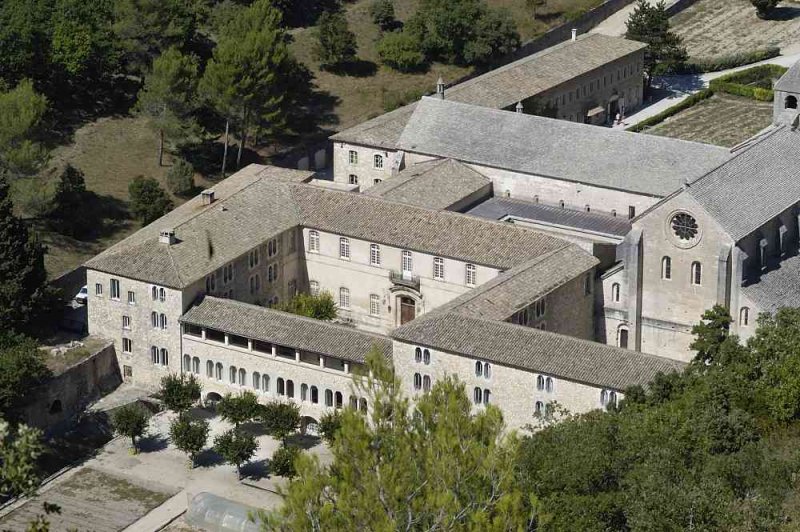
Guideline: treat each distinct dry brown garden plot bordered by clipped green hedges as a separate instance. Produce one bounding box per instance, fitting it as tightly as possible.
[643,94,772,148]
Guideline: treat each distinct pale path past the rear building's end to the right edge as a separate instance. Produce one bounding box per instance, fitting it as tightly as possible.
[613,52,800,129]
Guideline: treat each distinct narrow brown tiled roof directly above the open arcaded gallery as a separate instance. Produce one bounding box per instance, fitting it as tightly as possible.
[181,296,392,364]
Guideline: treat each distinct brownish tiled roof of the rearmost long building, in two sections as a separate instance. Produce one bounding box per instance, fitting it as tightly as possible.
[331,33,645,149]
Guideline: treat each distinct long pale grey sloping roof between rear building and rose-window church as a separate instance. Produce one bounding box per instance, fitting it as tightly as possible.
[398,97,731,197]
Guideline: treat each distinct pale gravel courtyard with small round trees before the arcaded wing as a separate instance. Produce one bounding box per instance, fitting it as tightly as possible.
[0,394,330,532]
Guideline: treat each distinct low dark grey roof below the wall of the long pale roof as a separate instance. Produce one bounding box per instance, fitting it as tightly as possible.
[467,197,631,236]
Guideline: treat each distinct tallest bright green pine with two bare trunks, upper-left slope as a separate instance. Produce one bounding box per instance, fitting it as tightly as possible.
[200,0,296,177]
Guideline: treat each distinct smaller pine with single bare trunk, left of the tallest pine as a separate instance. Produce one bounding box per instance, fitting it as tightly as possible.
[135,47,199,166]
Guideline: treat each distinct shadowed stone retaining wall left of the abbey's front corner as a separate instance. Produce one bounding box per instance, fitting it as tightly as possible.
[21,343,122,433]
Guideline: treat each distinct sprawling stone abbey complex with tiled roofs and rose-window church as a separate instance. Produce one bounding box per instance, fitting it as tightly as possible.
[86,37,800,428]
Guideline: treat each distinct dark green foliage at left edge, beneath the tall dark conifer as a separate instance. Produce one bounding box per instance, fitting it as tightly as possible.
[0,331,52,420]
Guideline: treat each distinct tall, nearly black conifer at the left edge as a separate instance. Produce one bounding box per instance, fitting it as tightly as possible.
[0,172,52,331]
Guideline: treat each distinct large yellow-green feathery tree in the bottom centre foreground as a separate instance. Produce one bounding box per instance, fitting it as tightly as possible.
[260,350,529,530]
